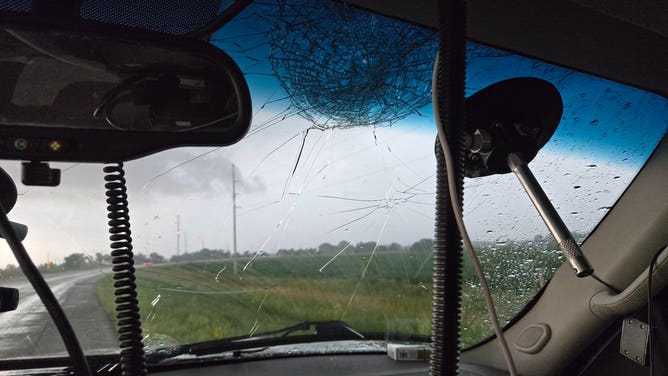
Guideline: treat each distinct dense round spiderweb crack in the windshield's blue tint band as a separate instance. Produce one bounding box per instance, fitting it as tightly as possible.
[268,0,434,128]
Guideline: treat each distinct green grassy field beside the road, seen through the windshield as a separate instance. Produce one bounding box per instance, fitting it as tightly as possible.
[97,252,544,347]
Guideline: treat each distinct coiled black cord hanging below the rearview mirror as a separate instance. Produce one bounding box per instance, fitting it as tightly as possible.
[103,163,147,376]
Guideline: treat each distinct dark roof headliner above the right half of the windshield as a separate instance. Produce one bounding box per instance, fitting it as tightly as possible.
[345,0,668,96]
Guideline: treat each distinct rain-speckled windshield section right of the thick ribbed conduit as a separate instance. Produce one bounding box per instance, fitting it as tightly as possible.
[462,43,668,346]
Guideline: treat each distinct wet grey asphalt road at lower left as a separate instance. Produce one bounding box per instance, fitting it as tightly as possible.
[0,270,118,359]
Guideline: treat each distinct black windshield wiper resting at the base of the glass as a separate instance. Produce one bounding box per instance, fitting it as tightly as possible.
[152,320,365,361]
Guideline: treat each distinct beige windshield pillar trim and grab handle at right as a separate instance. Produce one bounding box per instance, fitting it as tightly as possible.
[461,136,668,375]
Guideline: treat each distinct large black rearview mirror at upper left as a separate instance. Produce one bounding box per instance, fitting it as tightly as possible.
[0,20,251,162]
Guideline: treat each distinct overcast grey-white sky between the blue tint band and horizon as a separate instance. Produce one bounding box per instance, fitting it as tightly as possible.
[0,111,648,265]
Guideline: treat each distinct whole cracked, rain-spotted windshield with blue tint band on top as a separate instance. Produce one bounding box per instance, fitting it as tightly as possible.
[0,1,668,358]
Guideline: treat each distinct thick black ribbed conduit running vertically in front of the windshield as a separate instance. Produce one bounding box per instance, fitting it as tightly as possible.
[430,0,466,376]
